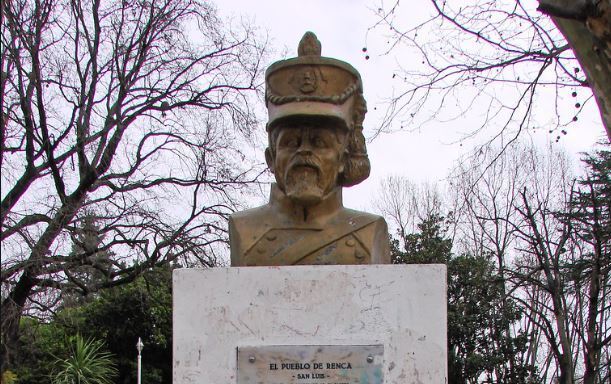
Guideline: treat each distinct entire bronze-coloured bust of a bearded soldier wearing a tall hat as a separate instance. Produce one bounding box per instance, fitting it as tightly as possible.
[229,32,390,266]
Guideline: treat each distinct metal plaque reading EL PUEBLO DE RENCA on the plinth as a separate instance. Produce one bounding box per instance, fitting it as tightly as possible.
[238,345,384,384]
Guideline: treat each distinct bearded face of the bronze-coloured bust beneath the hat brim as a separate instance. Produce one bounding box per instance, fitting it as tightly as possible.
[269,120,346,205]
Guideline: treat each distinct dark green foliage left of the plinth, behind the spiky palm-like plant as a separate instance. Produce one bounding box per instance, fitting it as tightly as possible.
[14,267,172,384]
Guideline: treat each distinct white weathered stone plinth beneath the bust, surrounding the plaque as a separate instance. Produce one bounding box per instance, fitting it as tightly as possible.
[174,265,447,384]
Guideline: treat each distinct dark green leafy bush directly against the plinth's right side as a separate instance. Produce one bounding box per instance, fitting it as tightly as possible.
[448,255,532,383]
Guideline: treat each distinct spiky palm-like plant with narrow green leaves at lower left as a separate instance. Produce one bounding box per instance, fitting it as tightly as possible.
[53,334,117,384]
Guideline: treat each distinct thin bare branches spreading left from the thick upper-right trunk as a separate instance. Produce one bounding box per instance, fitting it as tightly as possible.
[372,0,611,148]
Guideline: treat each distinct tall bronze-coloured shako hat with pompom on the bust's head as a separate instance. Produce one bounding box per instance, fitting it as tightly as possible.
[265,32,366,130]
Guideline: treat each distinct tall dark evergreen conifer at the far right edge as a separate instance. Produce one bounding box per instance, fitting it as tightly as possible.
[561,150,611,384]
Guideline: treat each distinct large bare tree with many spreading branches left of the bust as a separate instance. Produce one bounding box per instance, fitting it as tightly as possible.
[0,0,265,367]
